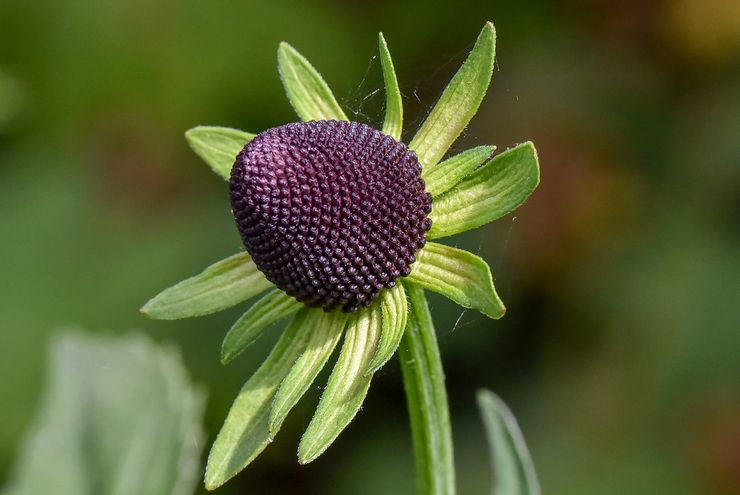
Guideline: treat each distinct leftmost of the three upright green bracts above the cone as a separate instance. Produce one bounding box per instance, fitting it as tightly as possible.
[278,41,349,120]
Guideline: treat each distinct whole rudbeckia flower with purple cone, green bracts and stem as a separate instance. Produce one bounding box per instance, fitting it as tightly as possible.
[142,23,539,493]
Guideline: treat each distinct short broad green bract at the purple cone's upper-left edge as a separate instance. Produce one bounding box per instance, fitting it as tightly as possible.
[185,126,254,180]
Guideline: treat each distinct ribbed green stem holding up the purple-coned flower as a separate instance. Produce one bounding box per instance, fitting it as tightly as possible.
[398,284,455,495]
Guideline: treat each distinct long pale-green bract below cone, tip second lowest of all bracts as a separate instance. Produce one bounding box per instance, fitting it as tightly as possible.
[298,305,381,464]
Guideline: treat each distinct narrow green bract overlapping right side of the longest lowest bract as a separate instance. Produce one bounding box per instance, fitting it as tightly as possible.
[269,309,347,432]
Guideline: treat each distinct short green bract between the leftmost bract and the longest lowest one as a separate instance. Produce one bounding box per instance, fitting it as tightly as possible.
[221,289,303,364]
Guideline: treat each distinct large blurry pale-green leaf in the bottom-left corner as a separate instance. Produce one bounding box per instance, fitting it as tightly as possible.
[3,333,204,495]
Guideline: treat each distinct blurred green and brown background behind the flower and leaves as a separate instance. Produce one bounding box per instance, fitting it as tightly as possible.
[0,0,740,495]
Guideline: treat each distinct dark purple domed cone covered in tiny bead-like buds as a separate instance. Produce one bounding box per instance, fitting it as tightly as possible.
[231,121,432,311]
